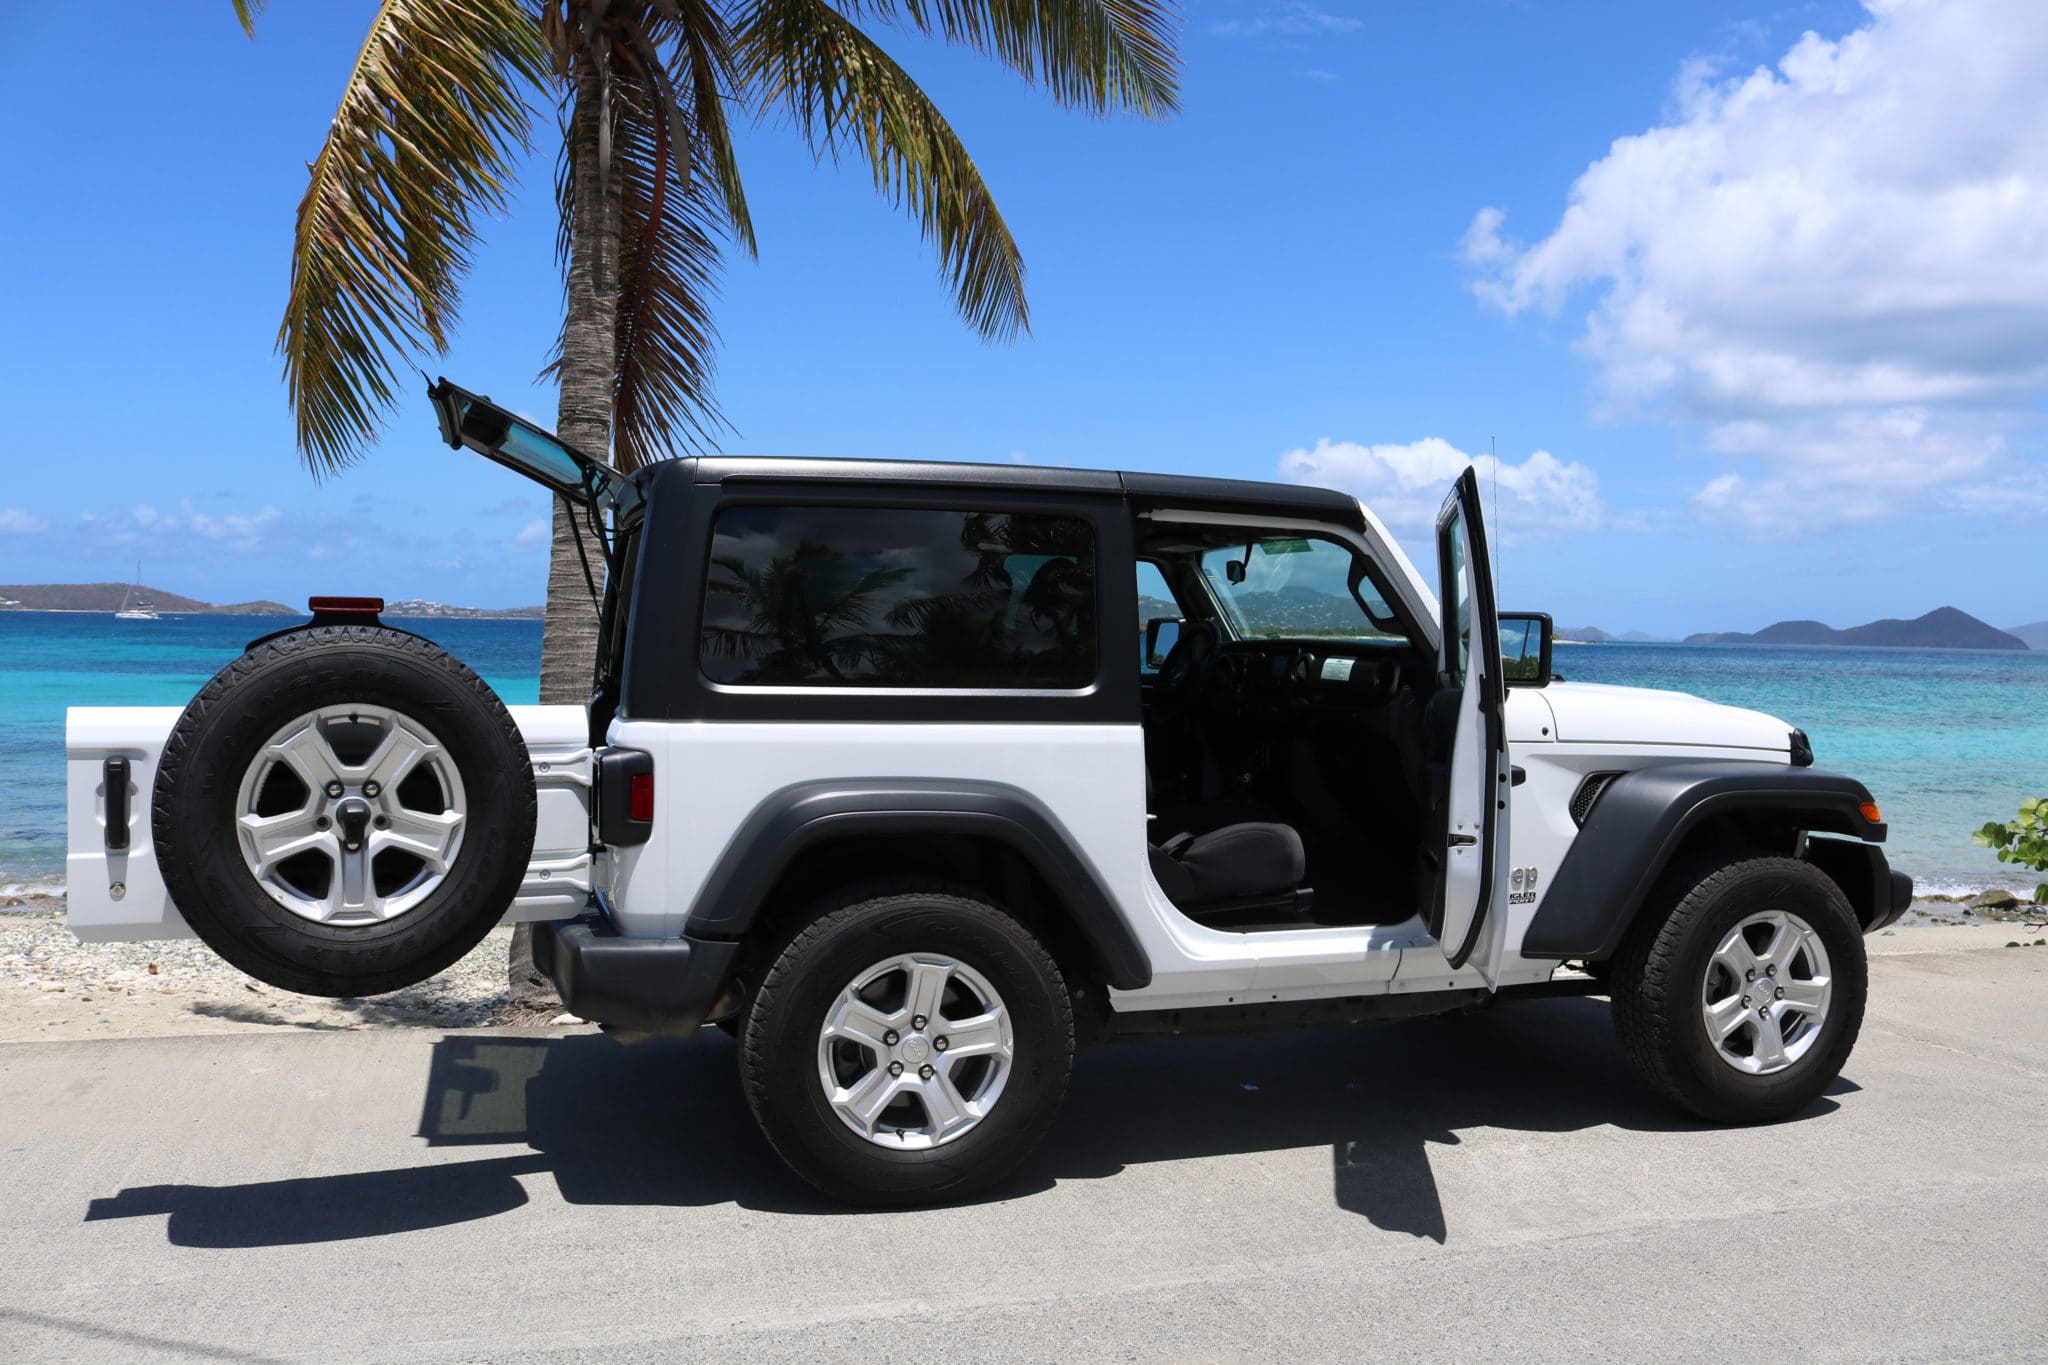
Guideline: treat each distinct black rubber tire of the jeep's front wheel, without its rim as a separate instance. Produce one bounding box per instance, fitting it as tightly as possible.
[1612,853,1870,1124]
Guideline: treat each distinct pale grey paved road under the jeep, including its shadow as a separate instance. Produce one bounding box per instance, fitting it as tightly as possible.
[0,931,2048,1365]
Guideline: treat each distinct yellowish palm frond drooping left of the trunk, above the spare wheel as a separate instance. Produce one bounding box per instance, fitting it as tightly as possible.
[284,0,549,473]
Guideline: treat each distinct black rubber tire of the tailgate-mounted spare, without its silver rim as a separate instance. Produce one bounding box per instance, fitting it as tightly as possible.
[150,626,535,997]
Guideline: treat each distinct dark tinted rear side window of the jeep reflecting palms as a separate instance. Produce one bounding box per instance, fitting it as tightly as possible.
[698,508,1096,690]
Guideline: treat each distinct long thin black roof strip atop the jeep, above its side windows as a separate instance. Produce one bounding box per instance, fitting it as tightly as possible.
[635,454,1364,526]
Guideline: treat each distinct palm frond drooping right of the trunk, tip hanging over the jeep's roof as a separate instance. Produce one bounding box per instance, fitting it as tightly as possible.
[733,0,1030,340]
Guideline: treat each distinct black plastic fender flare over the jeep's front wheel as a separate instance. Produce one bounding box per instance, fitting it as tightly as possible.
[1522,759,1890,962]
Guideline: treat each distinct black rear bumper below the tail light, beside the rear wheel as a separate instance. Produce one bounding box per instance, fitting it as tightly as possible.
[532,915,739,1033]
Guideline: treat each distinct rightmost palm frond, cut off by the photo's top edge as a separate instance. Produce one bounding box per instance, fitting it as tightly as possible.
[842,0,1180,119]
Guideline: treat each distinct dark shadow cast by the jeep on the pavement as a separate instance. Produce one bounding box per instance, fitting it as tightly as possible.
[86,999,1855,1248]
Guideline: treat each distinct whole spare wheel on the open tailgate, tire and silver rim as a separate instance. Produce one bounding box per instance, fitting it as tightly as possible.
[150,626,535,997]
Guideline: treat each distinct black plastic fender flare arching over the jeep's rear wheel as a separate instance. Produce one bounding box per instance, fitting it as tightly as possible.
[684,778,1151,990]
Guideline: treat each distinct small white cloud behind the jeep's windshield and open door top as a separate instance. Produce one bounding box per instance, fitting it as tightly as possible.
[1280,436,1608,542]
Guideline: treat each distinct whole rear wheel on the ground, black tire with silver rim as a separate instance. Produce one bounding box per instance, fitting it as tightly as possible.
[739,890,1073,1205]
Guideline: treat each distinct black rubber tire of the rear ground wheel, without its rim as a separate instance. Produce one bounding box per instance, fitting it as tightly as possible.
[739,888,1073,1207]
